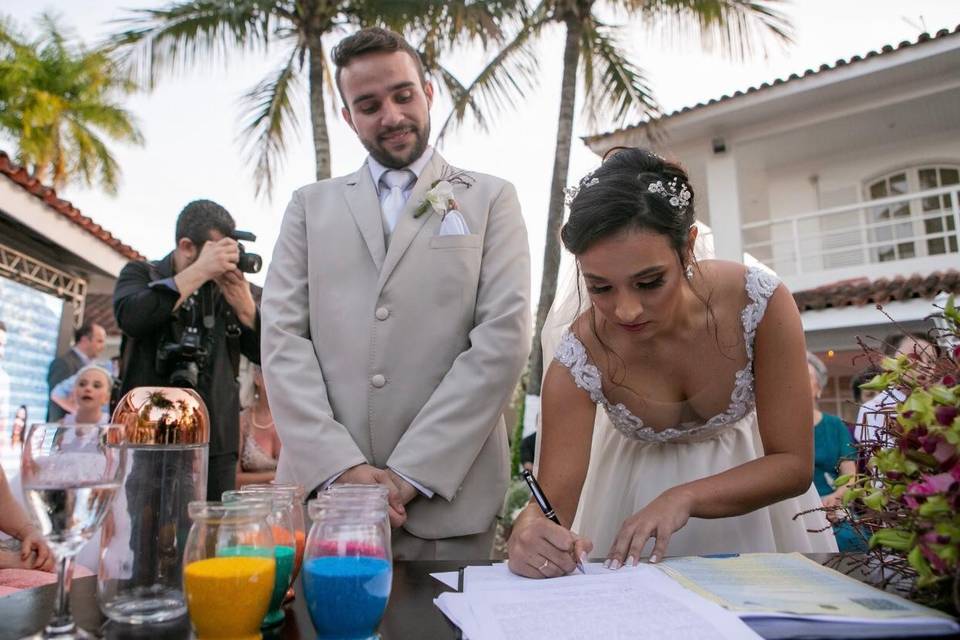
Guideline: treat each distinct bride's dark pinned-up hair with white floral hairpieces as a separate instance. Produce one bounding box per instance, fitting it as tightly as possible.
[560,147,694,268]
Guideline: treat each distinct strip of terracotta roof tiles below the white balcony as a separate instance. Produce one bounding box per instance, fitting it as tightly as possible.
[793,269,960,312]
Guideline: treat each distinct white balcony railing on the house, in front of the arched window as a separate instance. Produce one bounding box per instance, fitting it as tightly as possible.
[743,185,960,276]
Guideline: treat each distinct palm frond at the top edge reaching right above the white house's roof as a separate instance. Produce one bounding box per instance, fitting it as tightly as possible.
[630,0,793,60]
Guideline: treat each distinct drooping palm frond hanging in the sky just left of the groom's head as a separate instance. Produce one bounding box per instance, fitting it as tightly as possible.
[241,47,300,197]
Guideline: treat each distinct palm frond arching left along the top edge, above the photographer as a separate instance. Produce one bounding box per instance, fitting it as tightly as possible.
[106,0,278,88]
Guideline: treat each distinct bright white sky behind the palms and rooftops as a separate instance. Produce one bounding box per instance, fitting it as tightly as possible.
[0,0,960,300]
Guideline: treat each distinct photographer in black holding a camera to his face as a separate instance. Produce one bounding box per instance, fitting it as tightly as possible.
[113,200,260,500]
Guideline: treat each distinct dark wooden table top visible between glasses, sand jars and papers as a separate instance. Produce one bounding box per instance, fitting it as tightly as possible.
[0,554,945,640]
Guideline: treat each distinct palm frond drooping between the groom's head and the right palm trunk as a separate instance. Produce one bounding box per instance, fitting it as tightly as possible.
[438,1,552,140]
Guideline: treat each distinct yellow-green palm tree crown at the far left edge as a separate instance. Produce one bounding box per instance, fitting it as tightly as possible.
[0,14,143,194]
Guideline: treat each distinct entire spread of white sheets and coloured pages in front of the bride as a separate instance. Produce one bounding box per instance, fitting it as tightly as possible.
[435,553,960,640]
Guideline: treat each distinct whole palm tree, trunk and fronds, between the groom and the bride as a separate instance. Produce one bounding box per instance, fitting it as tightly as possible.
[440,0,790,396]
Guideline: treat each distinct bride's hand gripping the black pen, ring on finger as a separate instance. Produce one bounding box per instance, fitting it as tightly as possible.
[507,503,593,578]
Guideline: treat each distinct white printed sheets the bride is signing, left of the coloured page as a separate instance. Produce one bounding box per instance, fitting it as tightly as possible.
[436,565,759,640]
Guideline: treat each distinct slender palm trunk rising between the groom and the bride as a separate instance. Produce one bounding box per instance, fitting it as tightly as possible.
[527,11,582,396]
